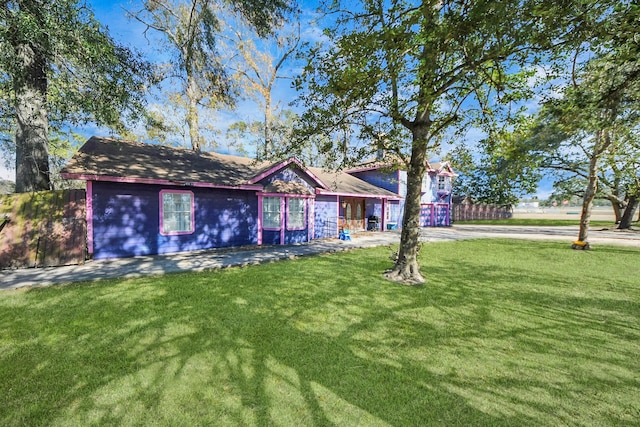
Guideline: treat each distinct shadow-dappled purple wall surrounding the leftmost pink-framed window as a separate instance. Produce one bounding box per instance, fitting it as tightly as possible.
[91,181,258,259]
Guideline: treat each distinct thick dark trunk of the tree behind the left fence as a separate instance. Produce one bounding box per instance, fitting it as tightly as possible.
[14,43,51,193]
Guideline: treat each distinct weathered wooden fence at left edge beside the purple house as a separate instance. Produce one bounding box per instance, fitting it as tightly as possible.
[0,190,87,269]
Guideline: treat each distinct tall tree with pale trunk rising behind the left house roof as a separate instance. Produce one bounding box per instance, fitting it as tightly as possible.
[130,0,291,151]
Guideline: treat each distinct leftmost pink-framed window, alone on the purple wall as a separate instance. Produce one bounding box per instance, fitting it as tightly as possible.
[160,190,194,235]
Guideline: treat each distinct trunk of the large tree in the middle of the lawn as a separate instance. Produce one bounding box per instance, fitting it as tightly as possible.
[385,132,427,285]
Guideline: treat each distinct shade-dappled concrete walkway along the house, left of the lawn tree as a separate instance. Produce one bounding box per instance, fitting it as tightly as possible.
[0,232,400,291]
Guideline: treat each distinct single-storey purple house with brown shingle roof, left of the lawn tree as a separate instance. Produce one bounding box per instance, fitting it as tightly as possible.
[61,137,403,259]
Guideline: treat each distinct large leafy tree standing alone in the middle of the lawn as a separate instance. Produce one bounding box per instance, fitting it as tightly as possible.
[299,0,592,284]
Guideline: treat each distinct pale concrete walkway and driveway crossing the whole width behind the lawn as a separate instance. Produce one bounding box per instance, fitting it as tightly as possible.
[0,225,640,290]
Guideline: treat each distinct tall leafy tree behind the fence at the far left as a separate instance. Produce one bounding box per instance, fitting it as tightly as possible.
[0,0,147,192]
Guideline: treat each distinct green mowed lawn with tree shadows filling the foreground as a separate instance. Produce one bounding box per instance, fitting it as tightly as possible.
[0,240,640,426]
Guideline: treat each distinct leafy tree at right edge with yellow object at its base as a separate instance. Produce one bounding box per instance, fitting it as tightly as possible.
[524,2,640,237]
